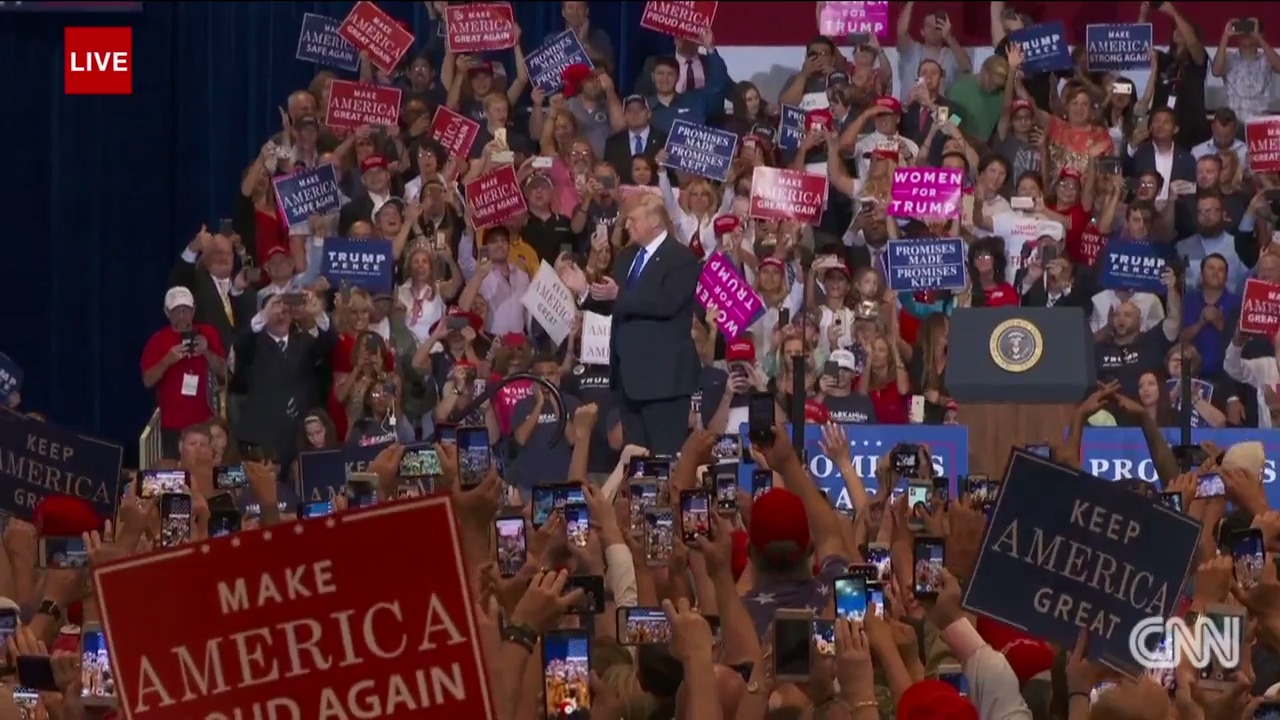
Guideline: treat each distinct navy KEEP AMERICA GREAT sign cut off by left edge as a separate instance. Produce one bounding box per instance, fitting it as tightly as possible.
[0,413,124,520]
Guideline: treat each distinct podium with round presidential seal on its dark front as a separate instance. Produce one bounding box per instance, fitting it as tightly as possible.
[946,307,1097,478]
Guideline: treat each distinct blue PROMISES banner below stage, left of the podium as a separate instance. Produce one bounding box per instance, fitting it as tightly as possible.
[737,423,969,509]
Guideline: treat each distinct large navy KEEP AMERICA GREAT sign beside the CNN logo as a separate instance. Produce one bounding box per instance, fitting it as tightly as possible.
[964,450,1201,674]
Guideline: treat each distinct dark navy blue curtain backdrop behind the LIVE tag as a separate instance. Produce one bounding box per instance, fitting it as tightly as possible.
[0,3,671,455]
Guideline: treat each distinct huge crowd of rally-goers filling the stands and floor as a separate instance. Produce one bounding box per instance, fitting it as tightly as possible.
[0,1,1280,720]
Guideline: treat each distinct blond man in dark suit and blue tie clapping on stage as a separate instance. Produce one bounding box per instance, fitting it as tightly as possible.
[564,195,701,454]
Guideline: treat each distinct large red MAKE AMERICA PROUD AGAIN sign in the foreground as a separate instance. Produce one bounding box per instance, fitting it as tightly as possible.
[93,497,495,720]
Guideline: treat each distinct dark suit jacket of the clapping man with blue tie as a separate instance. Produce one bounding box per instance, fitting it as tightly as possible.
[584,236,703,402]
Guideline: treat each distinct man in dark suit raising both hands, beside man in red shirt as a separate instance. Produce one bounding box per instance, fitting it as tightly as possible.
[232,293,337,468]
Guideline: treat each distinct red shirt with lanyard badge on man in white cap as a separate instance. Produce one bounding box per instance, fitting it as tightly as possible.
[142,324,227,430]
